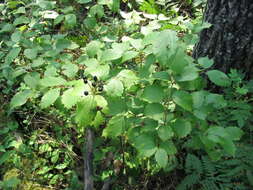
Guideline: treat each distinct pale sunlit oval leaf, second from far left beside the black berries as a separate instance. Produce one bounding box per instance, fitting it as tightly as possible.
[40,88,60,108]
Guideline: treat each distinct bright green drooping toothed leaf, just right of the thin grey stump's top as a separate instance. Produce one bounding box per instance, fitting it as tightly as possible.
[102,115,125,138]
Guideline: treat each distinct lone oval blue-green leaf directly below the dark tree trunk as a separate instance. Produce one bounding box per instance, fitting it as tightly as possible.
[206,70,231,87]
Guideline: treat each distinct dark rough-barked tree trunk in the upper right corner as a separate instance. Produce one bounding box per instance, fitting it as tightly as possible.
[193,0,253,79]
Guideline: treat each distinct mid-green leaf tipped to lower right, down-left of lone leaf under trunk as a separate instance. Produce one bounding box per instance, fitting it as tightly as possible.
[172,90,193,111]
